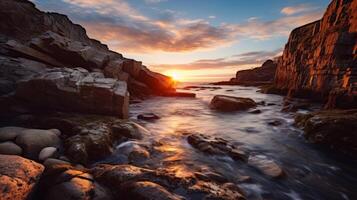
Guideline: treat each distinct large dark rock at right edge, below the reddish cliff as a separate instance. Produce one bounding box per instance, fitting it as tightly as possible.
[295,109,357,156]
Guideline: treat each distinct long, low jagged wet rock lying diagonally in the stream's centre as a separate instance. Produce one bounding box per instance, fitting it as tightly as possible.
[187,134,248,161]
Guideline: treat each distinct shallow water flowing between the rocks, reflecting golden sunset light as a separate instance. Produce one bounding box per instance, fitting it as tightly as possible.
[114,86,357,200]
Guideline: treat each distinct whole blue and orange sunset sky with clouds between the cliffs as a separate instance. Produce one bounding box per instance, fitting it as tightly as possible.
[32,0,330,82]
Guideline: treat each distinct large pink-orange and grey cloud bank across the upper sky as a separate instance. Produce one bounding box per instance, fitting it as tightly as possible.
[37,0,322,53]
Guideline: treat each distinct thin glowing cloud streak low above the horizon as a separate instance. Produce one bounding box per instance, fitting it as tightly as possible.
[153,48,283,71]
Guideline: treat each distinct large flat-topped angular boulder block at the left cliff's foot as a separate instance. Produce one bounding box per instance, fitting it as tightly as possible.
[16,68,129,118]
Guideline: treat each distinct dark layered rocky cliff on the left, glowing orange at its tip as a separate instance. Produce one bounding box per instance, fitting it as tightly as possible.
[0,0,177,118]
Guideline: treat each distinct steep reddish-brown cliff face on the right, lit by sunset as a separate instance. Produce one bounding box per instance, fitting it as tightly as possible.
[275,0,357,108]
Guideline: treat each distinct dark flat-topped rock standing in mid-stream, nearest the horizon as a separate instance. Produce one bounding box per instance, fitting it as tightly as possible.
[210,95,256,112]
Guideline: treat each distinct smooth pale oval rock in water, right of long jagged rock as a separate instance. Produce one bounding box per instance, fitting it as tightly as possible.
[248,155,284,178]
